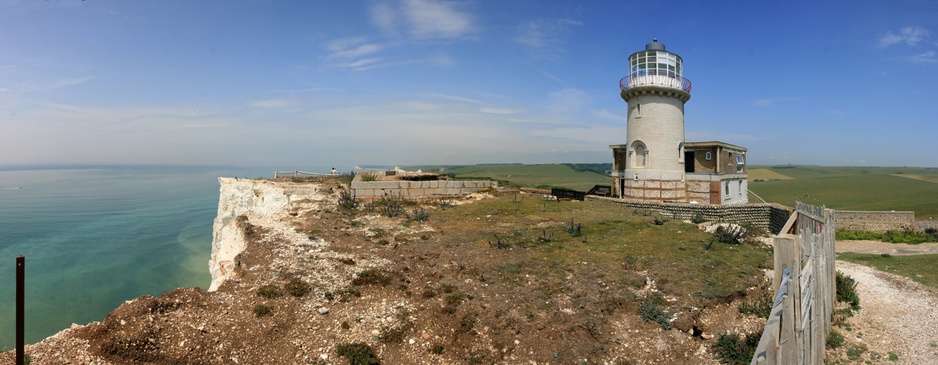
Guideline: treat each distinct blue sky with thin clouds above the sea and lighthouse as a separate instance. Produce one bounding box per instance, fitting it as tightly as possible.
[0,0,938,169]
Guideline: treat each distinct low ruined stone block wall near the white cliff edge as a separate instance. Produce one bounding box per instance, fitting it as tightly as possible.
[352,180,494,198]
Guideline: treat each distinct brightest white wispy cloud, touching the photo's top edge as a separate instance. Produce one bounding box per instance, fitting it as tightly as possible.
[370,0,476,39]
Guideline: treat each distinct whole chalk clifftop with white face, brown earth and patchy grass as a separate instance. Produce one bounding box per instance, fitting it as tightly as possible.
[0,178,771,365]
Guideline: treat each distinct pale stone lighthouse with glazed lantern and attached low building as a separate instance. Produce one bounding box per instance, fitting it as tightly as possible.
[610,39,748,204]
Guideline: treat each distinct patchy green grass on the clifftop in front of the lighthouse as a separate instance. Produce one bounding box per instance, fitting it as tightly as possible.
[438,194,772,310]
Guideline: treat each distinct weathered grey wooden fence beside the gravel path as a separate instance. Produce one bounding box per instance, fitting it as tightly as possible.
[751,202,836,365]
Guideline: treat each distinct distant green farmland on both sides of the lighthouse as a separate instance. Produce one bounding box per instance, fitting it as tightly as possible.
[408,163,938,218]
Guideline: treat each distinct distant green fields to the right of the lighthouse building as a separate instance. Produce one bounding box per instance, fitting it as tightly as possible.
[749,166,938,218]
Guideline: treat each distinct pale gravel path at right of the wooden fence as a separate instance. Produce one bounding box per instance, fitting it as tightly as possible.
[837,260,938,364]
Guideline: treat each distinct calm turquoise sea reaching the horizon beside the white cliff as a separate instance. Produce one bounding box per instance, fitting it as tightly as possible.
[0,166,329,351]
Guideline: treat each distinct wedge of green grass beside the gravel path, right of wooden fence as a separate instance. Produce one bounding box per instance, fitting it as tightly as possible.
[837,252,938,288]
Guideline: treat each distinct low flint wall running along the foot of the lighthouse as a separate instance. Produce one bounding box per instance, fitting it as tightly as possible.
[586,195,793,234]
